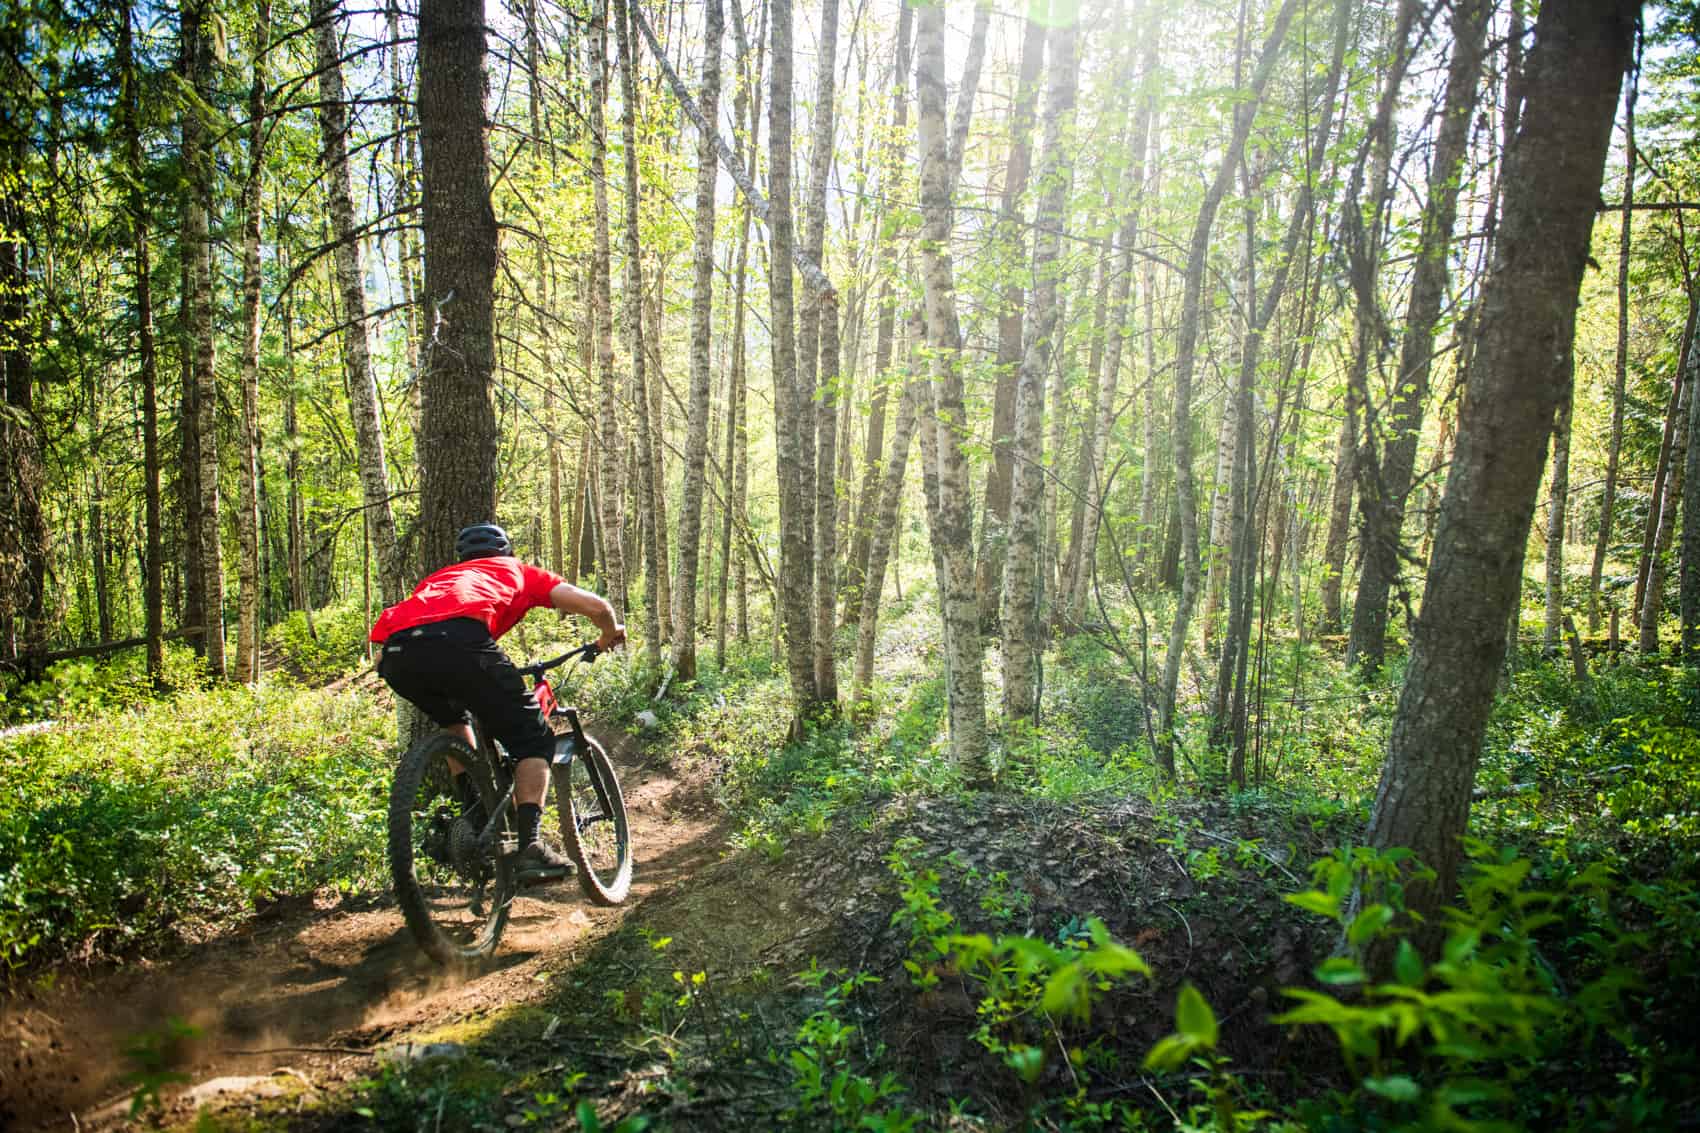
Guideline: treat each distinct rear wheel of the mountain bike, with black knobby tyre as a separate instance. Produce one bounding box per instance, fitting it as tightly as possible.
[389,733,513,965]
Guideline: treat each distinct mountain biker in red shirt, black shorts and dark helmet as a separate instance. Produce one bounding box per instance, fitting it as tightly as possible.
[369,524,626,883]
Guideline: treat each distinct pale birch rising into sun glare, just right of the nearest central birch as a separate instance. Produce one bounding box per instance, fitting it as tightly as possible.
[1003,22,1080,720]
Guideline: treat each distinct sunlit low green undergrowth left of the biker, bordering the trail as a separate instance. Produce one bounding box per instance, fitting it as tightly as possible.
[0,663,394,975]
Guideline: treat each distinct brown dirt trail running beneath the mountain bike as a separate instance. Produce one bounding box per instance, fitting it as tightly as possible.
[0,731,724,1130]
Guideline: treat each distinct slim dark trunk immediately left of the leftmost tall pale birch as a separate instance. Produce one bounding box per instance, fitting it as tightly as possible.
[117,7,165,687]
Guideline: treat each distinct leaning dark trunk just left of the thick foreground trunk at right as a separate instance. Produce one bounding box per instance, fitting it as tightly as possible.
[1348,0,1494,672]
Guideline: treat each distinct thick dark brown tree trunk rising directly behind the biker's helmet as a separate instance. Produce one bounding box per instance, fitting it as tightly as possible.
[418,0,496,570]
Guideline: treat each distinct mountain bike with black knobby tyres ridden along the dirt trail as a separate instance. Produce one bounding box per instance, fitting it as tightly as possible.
[389,641,632,965]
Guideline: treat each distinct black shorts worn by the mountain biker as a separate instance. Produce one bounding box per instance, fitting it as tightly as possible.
[377,618,554,759]
